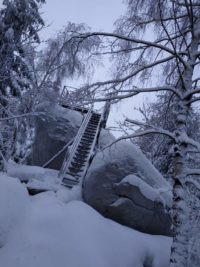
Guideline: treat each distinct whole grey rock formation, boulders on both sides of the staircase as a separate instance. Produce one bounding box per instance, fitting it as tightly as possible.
[32,103,171,235]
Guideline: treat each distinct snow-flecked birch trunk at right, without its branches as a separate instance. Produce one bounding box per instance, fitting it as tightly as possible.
[170,23,199,267]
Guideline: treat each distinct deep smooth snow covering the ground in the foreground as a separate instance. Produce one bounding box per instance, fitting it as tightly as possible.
[0,173,171,267]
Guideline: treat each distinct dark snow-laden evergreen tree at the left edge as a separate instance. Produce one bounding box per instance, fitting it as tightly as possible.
[0,0,45,168]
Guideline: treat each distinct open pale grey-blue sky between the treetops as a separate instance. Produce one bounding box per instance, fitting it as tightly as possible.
[42,0,125,35]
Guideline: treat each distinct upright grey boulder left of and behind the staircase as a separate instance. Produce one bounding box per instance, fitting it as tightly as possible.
[31,103,83,170]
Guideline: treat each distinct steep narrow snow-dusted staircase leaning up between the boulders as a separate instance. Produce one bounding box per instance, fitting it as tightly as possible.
[59,109,102,189]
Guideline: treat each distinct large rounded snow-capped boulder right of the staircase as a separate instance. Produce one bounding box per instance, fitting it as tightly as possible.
[83,141,171,238]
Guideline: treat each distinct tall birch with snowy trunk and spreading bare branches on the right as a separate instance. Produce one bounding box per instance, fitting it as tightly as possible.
[66,0,200,267]
